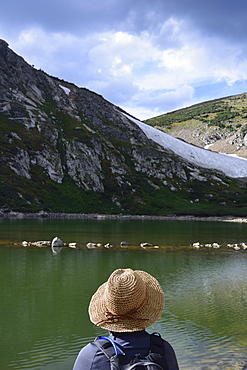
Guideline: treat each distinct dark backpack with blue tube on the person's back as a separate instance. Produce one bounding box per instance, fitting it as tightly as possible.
[94,333,169,370]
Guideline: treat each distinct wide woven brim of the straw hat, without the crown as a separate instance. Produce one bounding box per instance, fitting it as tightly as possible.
[88,270,165,332]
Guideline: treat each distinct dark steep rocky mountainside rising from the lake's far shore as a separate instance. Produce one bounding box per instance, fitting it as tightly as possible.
[0,40,247,215]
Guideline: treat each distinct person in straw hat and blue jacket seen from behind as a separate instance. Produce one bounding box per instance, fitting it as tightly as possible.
[73,268,179,370]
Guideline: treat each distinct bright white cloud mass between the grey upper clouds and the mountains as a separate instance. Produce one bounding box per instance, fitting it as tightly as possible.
[2,10,247,119]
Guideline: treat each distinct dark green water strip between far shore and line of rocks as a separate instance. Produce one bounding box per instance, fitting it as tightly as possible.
[0,219,247,246]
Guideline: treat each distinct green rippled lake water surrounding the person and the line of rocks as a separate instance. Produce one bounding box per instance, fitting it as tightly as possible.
[0,220,247,370]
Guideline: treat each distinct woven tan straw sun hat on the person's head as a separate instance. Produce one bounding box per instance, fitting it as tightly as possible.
[88,269,165,332]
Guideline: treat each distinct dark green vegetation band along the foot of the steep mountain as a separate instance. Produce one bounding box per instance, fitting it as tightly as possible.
[0,143,247,216]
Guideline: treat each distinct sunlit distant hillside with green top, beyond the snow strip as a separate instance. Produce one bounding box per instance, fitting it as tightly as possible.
[146,93,247,158]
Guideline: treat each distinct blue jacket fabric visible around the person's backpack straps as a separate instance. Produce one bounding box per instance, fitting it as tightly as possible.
[73,330,179,370]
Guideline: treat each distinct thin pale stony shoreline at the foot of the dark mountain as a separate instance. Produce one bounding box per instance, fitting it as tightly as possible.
[0,211,247,223]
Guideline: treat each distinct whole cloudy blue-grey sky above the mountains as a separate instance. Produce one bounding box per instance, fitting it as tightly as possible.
[0,0,247,120]
